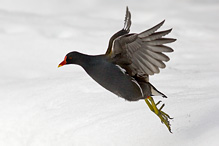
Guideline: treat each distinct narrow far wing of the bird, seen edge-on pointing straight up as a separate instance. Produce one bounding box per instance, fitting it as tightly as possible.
[105,7,131,55]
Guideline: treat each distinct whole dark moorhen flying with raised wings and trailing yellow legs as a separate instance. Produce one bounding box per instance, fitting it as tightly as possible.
[58,7,176,133]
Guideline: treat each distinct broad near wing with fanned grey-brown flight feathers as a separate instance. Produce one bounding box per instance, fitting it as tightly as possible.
[111,21,176,79]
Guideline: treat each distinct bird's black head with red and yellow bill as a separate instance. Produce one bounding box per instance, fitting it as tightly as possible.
[58,51,79,67]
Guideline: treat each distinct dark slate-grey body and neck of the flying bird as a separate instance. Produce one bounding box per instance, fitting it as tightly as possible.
[69,52,144,101]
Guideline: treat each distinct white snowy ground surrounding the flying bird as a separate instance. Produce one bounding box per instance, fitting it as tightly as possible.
[0,0,219,146]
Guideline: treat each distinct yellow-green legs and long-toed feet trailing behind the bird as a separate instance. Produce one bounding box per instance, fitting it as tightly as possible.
[145,96,173,133]
